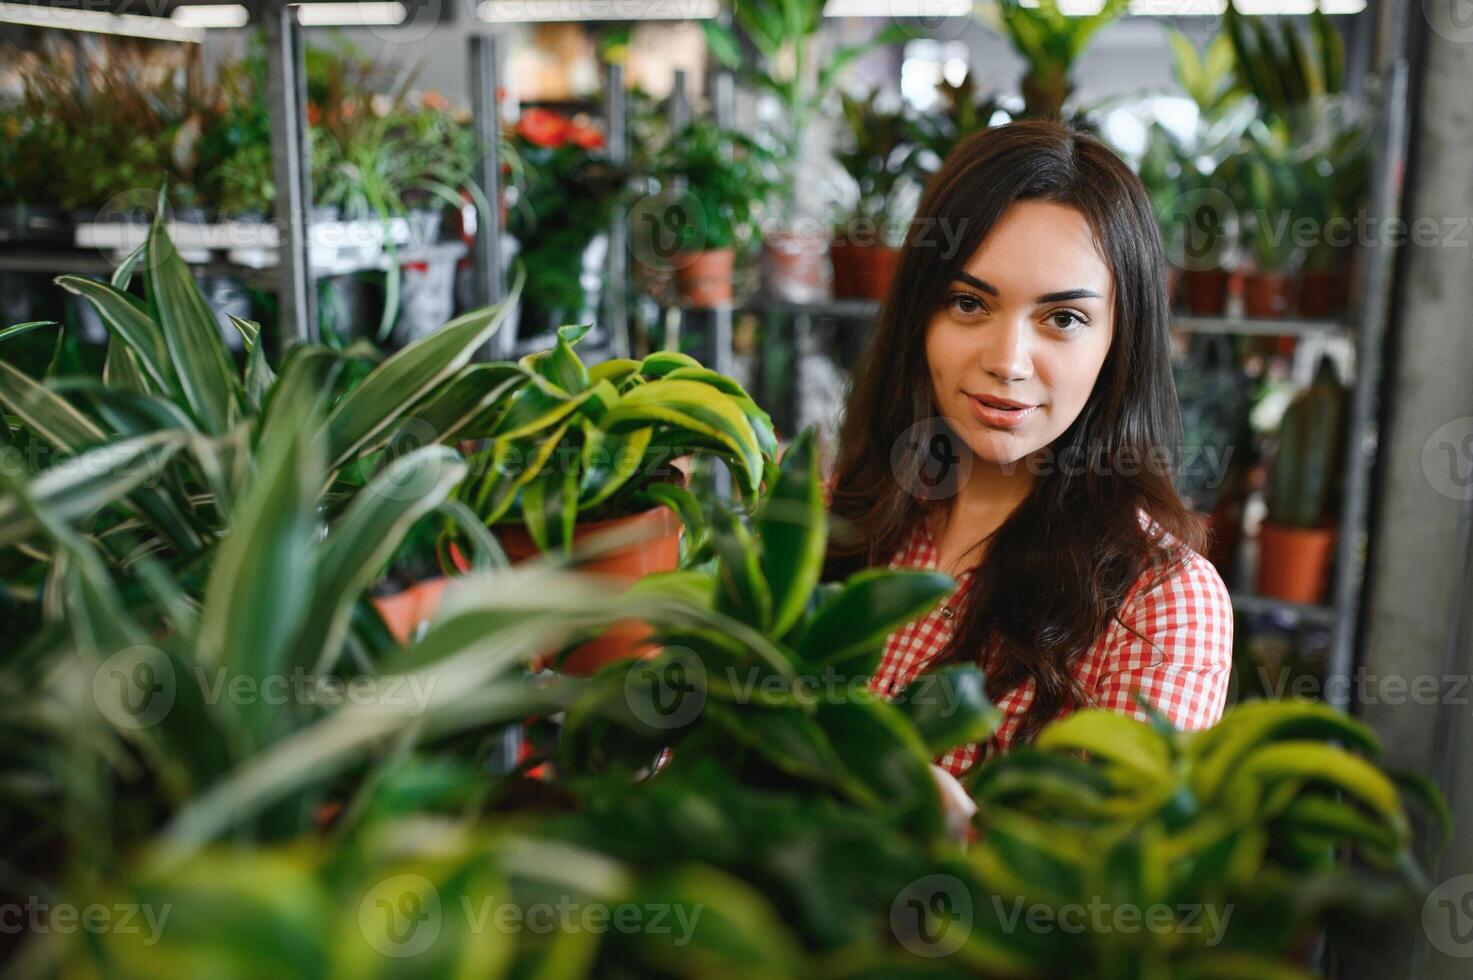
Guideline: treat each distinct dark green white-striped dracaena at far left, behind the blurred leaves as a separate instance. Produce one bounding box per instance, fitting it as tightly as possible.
[0,196,520,616]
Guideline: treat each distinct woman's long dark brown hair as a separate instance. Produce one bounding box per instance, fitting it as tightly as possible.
[825,121,1206,743]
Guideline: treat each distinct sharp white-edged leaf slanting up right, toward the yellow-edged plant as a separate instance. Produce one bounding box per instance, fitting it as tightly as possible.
[327,276,521,472]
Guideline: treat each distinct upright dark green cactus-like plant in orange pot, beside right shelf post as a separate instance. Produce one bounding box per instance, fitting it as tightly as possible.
[1258,358,1345,603]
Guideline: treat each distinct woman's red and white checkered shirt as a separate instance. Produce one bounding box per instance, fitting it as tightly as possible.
[871,511,1233,775]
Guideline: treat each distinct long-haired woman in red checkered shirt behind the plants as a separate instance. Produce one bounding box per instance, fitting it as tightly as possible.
[826,122,1233,774]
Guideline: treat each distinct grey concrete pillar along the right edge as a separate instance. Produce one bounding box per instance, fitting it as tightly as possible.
[1336,9,1473,980]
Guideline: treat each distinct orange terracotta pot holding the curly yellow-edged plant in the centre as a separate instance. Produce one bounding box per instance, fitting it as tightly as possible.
[451,507,681,676]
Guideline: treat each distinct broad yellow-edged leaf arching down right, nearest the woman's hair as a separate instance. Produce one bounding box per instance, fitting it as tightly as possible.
[602,379,763,497]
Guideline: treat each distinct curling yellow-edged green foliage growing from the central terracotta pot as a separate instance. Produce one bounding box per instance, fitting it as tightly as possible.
[452,333,776,551]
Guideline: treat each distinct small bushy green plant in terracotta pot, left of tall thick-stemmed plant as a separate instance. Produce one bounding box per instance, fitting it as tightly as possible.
[655,119,775,307]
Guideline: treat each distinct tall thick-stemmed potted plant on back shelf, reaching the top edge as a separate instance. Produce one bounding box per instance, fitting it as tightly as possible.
[701,0,909,302]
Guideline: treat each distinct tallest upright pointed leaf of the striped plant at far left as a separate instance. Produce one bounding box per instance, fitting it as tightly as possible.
[143,200,240,435]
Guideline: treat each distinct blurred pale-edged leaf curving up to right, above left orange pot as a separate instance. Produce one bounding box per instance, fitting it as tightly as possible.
[295,445,465,676]
